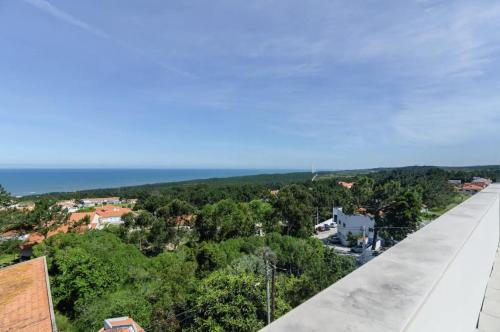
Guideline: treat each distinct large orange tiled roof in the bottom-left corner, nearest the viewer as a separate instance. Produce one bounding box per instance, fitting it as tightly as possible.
[0,257,56,332]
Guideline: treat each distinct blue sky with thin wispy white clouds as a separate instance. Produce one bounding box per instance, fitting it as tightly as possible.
[0,0,500,169]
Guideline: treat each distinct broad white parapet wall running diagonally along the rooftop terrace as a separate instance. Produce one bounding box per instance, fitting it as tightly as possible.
[262,184,500,332]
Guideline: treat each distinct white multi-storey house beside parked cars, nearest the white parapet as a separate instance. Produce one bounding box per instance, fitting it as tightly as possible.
[333,207,378,246]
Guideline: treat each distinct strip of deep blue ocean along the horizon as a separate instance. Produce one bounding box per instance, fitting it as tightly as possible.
[0,169,293,196]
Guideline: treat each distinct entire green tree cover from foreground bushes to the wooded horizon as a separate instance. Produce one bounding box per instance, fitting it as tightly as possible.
[0,167,497,331]
